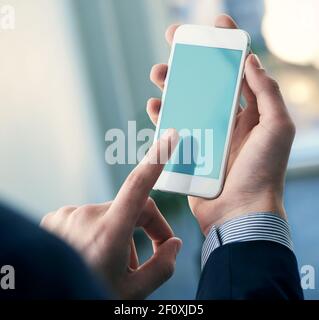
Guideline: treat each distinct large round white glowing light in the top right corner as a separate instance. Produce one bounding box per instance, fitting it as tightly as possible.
[263,0,319,65]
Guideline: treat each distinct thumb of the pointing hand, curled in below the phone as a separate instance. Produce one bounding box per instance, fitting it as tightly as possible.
[132,237,182,299]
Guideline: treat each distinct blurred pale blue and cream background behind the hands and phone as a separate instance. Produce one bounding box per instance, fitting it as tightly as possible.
[0,0,319,299]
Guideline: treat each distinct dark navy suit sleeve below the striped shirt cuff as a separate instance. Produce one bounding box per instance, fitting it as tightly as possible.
[197,241,303,300]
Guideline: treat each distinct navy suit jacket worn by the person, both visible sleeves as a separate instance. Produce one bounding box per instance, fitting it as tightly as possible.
[0,205,303,299]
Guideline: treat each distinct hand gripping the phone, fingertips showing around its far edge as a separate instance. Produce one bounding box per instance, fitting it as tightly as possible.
[147,15,295,235]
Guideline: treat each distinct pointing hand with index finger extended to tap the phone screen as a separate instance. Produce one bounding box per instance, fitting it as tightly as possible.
[41,129,182,299]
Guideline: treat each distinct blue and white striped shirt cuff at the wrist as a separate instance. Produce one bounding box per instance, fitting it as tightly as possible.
[202,212,293,269]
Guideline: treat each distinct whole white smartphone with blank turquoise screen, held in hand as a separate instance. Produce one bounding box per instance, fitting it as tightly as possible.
[154,25,250,199]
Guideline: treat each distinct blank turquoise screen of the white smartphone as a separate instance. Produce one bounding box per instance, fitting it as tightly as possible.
[159,44,243,179]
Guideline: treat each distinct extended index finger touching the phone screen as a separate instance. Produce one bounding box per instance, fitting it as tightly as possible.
[108,129,179,224]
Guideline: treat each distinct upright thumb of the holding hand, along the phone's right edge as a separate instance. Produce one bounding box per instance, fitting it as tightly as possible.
[245,54,288,119]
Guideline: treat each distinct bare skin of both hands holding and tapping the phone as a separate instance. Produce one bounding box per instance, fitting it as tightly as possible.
[41,15,295,299]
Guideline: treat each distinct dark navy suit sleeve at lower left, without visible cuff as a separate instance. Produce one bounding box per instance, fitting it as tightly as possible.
[0,205,108,300]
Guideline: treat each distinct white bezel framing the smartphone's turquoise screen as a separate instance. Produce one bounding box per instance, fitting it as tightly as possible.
[153,25,250,199]
